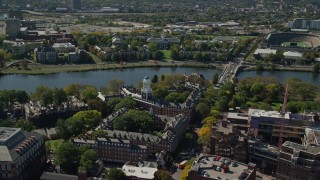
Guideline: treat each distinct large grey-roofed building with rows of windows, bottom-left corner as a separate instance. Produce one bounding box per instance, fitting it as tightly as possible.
[0,127,46,180]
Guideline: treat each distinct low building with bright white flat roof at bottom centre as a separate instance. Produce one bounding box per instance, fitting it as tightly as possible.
[122,161,158,180]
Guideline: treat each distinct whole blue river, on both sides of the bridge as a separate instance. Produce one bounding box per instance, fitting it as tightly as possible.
[0,67,320,92]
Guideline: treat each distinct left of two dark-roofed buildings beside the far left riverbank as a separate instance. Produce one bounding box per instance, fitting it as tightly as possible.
[34,46,58,63]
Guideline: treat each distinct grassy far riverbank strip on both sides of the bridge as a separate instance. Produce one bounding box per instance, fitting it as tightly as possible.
[0,60,313,75]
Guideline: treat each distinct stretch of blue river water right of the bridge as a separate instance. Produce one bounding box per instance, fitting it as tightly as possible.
[237,71,320,85]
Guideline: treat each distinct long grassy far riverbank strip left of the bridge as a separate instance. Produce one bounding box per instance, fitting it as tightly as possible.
[0,60,223,75]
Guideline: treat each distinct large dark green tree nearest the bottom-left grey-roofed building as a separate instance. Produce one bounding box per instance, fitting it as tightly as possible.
[55,142,80,174]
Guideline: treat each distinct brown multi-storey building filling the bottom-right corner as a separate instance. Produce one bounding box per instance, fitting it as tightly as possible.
[277,141,320,180]
